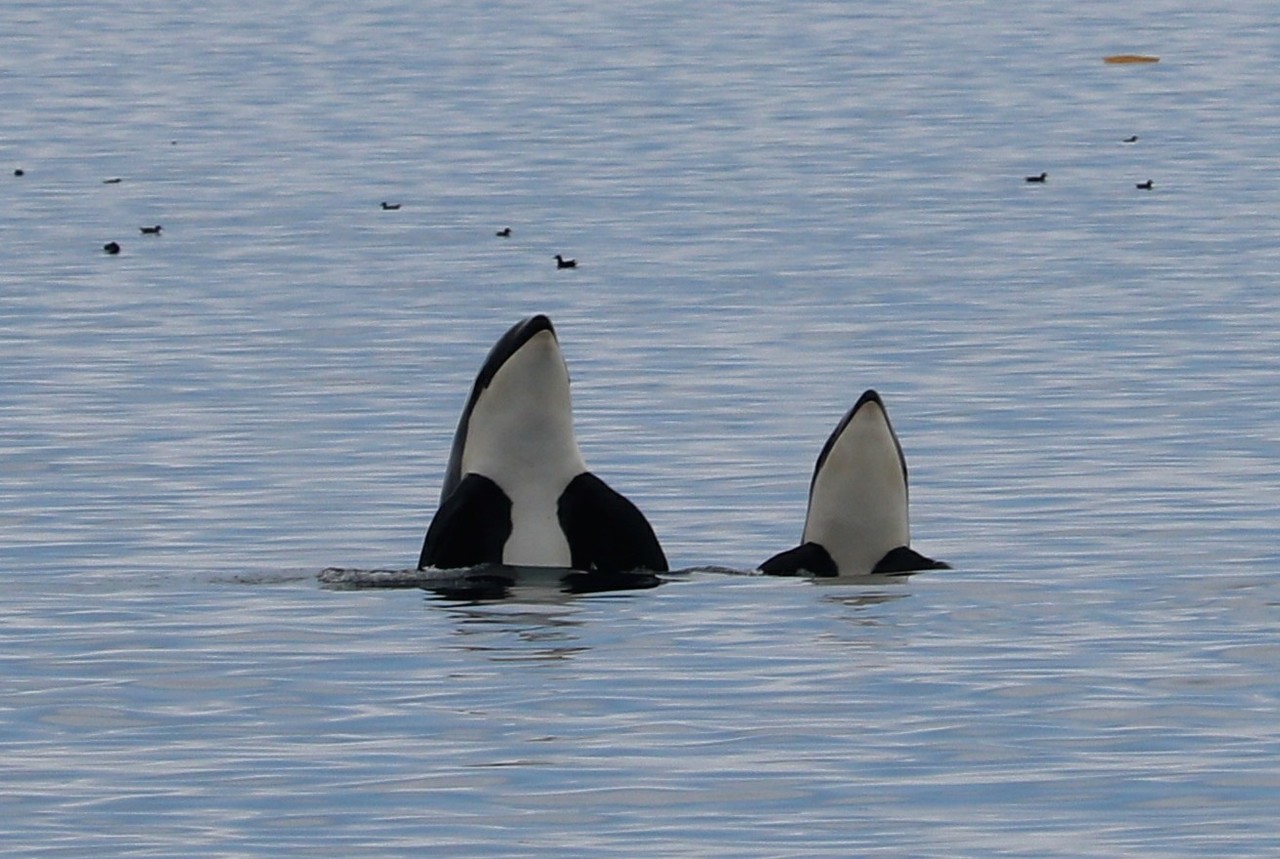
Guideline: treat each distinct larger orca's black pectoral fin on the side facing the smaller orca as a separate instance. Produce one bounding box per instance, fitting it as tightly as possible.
[556,471,668,572]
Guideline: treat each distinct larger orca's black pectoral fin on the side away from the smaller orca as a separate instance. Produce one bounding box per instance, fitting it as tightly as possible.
[417,474,511,570]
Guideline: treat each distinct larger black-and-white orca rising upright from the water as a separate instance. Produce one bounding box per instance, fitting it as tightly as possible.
[417,315,668,577]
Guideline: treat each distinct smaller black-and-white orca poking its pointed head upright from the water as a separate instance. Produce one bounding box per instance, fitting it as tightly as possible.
[759,390,950,576]
